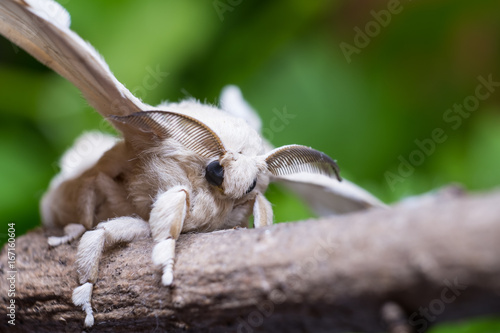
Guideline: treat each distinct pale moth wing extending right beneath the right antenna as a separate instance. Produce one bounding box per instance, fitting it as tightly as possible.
[272,172,387,216]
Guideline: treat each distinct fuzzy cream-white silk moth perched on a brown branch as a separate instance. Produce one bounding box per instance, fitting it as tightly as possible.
[0,0,383,327]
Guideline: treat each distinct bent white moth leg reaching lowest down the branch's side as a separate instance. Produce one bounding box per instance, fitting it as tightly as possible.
[72,217,150,327]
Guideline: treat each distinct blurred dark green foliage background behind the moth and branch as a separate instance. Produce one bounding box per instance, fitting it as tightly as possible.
[0,0,500,332]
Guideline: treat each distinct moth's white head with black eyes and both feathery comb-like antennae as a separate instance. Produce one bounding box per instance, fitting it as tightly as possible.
[111,111,340,199]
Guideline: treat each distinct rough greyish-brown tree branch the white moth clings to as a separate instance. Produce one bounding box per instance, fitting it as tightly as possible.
[0,188,500,332]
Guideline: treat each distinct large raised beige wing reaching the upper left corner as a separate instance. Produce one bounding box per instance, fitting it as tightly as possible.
[0,0,147,117]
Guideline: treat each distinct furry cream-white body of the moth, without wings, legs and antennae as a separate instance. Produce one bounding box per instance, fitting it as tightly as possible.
[41,101,269,232]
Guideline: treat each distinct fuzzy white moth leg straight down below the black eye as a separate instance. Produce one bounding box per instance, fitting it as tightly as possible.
[149,186,189,286]
